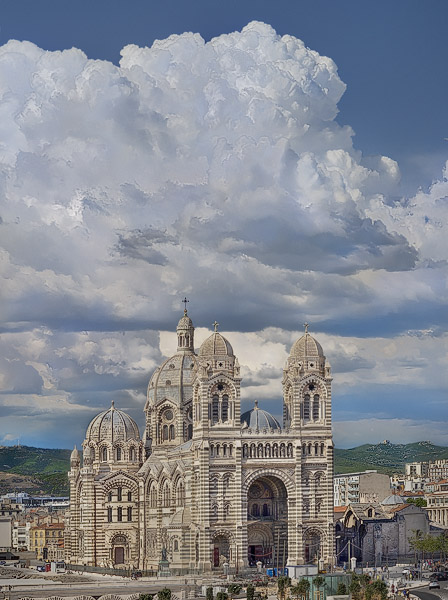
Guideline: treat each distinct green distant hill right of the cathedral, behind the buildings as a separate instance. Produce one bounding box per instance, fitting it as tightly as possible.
[334,442,448,474]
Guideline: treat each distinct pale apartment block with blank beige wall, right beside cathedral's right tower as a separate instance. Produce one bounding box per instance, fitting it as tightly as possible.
[333,470,390,506]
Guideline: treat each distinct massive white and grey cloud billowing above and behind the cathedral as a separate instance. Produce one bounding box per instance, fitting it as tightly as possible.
[0,22,447,446]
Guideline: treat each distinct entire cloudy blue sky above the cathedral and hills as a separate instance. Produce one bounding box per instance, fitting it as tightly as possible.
[0,0,448,448]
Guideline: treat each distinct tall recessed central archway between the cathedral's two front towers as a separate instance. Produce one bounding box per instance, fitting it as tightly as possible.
[247,475,288,568]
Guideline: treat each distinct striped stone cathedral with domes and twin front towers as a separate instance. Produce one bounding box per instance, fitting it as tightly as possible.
[66,310,335,574]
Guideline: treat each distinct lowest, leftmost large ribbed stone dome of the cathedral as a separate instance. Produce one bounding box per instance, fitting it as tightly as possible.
[86,403,140,442]
